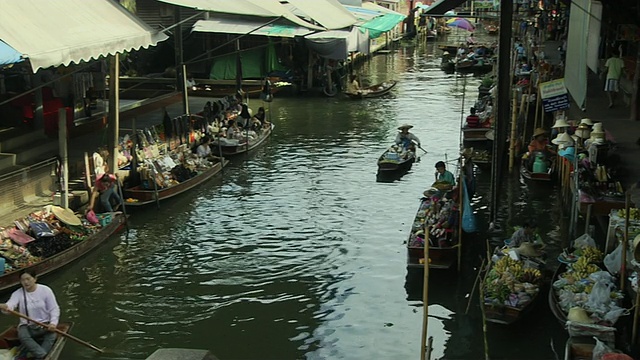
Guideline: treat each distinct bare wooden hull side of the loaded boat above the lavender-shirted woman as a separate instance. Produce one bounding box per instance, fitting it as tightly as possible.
[0,213,126,292]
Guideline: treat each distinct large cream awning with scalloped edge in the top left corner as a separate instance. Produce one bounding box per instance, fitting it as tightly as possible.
[0,0,167,72]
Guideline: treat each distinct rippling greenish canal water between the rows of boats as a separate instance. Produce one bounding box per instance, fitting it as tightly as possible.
[2,38,565,360]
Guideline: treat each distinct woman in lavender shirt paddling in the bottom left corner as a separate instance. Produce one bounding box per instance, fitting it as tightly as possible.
[0,270,60,359]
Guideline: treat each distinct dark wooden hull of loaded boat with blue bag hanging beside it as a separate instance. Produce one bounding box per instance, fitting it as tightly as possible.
[407,198,461,269]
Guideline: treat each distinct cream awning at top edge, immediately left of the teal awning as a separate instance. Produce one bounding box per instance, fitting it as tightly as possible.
[288,0,358,30]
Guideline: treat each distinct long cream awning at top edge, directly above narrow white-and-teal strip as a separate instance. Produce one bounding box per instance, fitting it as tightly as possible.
[159,0,325,30]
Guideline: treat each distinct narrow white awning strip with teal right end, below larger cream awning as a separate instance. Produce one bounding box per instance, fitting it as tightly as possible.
[193,18,313,38]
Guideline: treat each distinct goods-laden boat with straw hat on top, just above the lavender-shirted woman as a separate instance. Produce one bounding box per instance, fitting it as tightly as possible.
[0,206,125,291]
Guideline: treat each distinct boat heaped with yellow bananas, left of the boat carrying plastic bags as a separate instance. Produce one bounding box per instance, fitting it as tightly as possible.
[483,253,542,325]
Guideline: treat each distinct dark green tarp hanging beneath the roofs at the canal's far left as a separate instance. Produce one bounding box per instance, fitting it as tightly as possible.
[209,43,287,80]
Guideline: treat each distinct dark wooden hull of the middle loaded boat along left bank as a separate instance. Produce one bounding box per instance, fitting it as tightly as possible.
[124,158,229,206]
